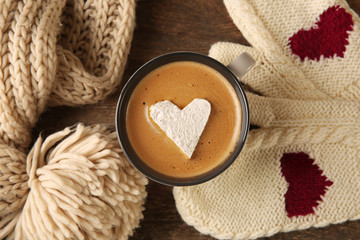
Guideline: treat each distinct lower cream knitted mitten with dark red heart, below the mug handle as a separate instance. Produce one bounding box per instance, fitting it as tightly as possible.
[174,94,360,239]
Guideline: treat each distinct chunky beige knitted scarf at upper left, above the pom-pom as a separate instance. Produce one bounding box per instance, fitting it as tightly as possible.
[0,0,135,147]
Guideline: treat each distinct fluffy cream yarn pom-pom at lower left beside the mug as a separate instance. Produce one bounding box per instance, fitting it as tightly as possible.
[11,125,148,239]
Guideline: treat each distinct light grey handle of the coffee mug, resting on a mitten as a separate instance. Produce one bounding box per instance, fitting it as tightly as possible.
[227,52,255,81]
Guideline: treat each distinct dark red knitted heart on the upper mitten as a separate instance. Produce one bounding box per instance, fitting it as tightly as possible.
[289,6,354,61]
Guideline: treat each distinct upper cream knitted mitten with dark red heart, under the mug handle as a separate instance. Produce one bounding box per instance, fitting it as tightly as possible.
[210,0,360,100]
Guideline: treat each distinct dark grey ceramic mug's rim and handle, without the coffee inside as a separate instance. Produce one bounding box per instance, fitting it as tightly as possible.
[115,52,255,186]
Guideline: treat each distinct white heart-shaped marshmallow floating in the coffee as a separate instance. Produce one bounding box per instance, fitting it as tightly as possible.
[150,98,211,158]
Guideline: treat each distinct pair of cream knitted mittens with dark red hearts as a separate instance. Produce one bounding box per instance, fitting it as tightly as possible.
[173,0,360,239]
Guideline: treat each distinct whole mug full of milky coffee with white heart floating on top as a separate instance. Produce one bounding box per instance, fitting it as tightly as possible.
[115,52,254,186]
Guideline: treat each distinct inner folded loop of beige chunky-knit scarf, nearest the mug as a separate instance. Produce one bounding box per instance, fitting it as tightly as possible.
[50,0,135,105]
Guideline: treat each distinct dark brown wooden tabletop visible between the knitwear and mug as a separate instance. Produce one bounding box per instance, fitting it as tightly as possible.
[34,0,360,240]
